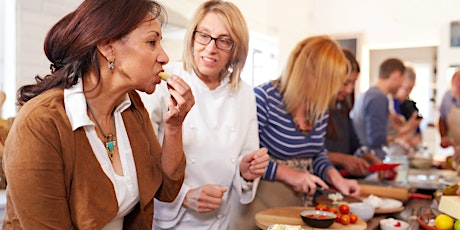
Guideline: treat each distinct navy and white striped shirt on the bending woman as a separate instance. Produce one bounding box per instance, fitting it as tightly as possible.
[254,82,333,180]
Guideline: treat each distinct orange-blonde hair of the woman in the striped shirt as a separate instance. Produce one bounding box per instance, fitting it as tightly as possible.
[279,36,351,123]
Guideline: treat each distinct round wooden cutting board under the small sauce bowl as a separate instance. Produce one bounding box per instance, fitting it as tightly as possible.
[255,207,367,230]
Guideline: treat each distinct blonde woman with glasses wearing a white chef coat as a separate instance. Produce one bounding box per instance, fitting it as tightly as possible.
[140,1,269,230]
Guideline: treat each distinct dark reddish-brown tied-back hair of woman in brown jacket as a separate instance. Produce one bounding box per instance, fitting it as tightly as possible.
[17,0,167,105]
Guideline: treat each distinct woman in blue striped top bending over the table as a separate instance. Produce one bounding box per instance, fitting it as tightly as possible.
[238,36,360,229]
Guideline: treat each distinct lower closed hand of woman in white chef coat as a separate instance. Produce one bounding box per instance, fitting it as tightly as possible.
[183,184,227,213]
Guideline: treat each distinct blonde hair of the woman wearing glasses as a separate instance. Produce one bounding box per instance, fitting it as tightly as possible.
[183,0,249,90]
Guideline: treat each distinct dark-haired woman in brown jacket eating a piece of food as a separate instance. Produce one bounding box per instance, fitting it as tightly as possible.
[3,0,194,229]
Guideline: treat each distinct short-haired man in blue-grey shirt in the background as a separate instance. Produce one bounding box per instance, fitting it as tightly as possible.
[350,58,406,160]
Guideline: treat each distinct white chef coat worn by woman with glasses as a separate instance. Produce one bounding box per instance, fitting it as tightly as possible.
[141,63,259,230]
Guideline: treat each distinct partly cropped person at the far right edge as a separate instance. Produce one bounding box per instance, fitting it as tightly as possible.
[438,70,460,148]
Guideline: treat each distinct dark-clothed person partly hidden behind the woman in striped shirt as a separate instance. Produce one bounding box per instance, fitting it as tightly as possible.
[325,49,383,177]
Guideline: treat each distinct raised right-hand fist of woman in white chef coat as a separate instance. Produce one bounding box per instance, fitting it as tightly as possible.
[240,148,270,181]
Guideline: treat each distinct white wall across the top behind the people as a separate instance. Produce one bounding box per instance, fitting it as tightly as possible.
[5,0,460,115]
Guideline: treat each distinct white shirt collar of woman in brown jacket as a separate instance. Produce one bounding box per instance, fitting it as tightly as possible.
[64,80,131,131]
